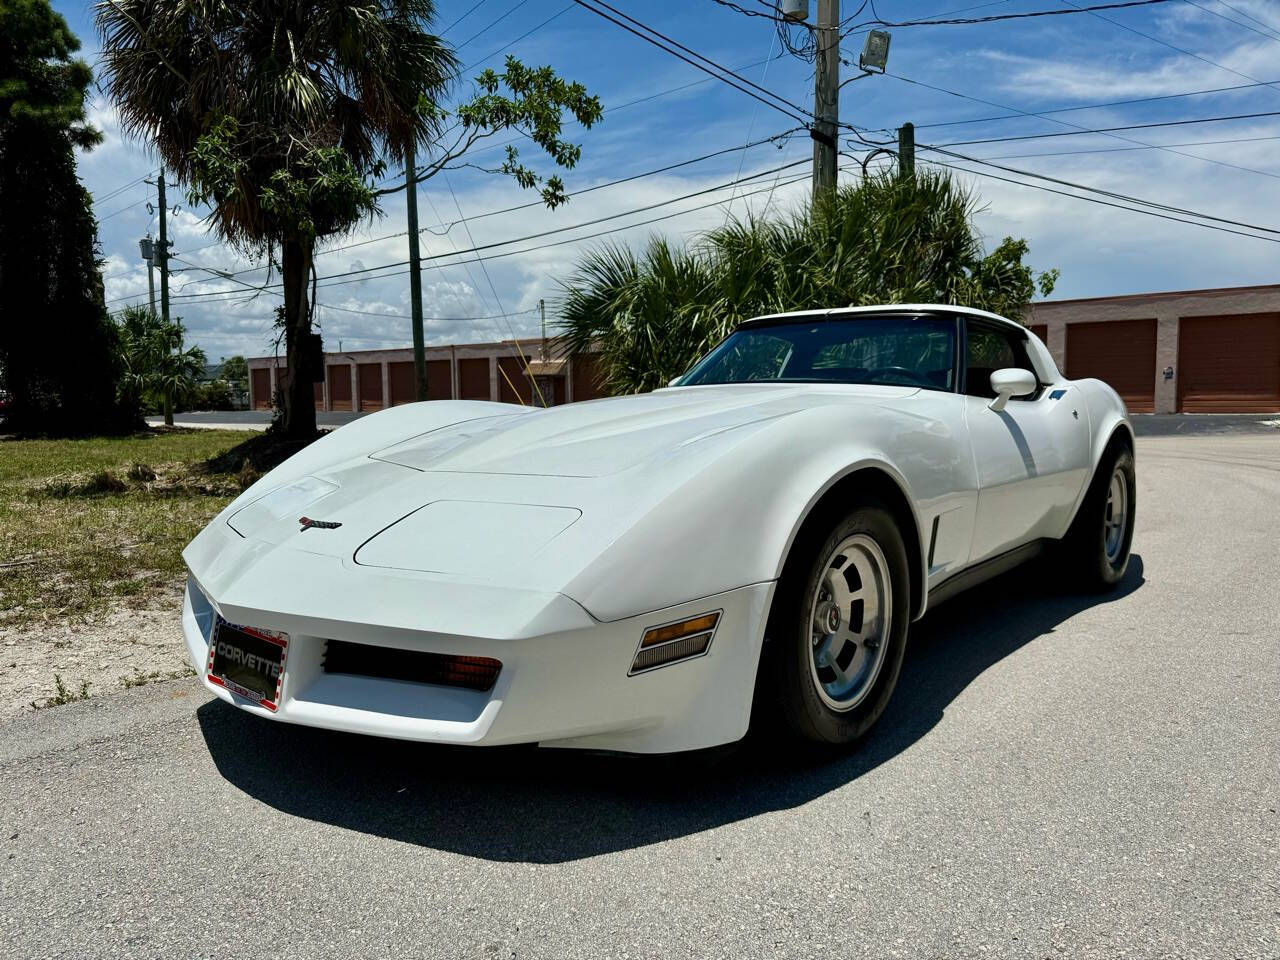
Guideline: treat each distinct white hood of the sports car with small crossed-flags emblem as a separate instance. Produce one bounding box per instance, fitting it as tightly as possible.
[184,384,915,612]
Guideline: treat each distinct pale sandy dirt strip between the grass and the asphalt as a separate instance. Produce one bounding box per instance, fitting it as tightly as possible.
[0,586,191,722]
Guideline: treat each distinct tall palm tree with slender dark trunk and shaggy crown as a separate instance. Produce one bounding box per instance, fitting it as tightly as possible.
[97,0,457,436]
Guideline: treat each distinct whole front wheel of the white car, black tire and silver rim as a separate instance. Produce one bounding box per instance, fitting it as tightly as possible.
[767,502,910,744]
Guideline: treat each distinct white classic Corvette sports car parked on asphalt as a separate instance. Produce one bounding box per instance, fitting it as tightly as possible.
[183,306,1135,753]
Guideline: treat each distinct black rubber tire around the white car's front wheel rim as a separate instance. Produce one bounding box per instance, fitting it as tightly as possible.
[760,500,911,745]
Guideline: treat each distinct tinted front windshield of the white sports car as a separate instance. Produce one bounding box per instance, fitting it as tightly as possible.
[680,314,956,390]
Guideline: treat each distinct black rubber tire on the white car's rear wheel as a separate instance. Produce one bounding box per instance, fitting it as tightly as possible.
[1064,442,1138,591]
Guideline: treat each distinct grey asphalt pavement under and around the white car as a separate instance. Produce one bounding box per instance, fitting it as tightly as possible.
[0,434,1280,960]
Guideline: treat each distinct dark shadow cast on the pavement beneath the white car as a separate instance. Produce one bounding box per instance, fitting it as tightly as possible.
[197,554,1144,863]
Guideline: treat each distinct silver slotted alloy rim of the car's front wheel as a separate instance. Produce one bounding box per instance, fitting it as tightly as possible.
[809,534,893,712]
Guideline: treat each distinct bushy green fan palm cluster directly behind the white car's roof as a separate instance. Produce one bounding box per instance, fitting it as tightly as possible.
[558,170,1057,393]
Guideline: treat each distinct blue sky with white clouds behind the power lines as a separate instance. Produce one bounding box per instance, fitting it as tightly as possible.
[79,7,1280,358]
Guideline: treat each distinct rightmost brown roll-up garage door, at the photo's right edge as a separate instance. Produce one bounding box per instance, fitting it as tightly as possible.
[1178,314,1280,413]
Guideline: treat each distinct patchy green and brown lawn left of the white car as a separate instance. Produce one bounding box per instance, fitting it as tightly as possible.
[0,430,252,627]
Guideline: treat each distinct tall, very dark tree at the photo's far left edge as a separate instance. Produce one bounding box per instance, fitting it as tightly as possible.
[0,0,129,434]
